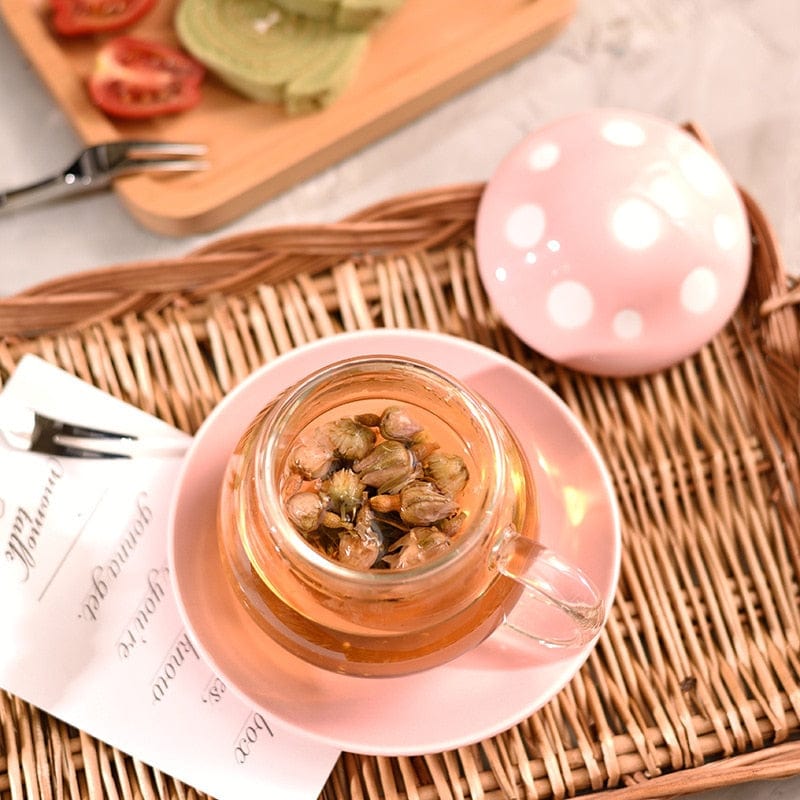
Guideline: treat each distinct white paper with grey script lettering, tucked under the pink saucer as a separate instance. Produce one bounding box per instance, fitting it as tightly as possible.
[0,356,338,800]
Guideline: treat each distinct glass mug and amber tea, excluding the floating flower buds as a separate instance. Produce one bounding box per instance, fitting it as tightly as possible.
[218,356,604,676]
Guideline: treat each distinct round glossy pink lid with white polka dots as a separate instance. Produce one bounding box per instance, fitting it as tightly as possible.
[476,109,751,376]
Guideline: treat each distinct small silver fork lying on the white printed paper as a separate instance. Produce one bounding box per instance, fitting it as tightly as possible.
[0,408,190,458]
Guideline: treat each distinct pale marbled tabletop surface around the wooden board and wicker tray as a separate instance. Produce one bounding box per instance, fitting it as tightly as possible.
[0,0,800,800]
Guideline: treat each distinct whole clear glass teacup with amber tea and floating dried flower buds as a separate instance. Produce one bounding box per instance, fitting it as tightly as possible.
[218,355,604,676]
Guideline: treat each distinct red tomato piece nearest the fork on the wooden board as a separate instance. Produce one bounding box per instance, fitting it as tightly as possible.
[89,36,205,119]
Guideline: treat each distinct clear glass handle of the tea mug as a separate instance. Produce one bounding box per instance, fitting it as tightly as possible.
[491,526,605,647]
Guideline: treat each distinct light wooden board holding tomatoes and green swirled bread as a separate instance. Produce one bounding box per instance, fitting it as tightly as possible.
[0,0,576,236]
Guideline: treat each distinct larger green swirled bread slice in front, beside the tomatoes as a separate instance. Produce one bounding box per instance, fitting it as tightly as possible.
[175,0,369,114]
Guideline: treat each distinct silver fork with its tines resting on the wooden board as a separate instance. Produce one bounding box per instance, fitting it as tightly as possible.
[0,140,208,214]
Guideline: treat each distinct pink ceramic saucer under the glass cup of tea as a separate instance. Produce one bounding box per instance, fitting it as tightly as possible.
[168,330,620,755]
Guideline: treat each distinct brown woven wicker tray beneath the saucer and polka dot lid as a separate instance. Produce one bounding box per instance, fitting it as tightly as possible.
[0,128,800,800]
